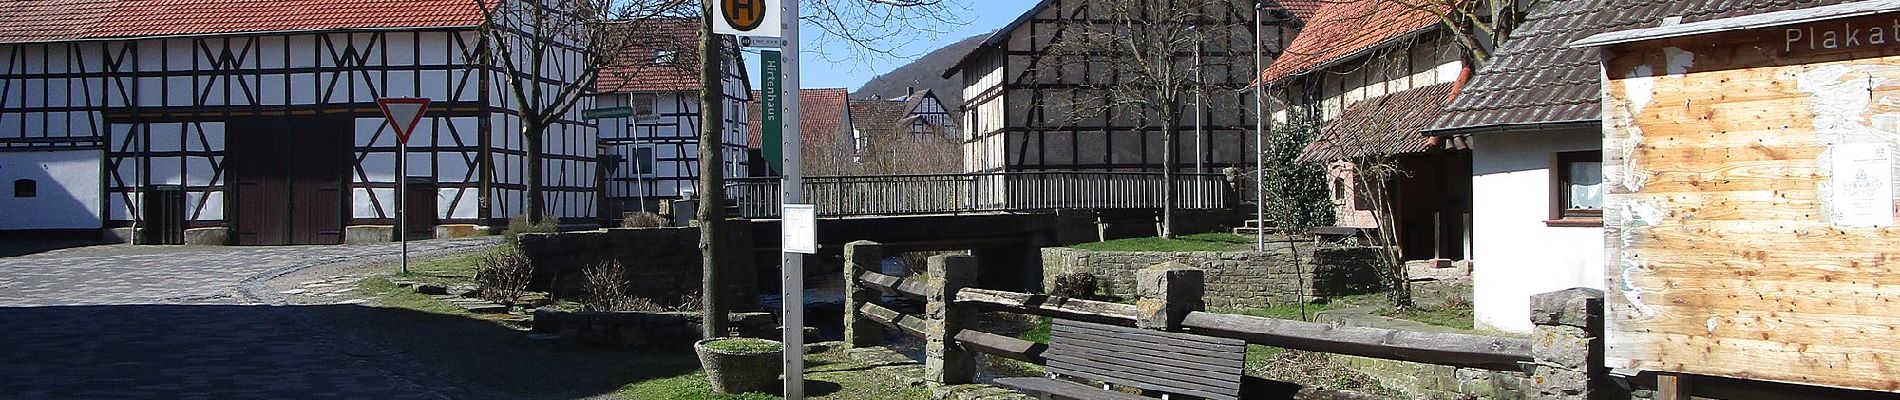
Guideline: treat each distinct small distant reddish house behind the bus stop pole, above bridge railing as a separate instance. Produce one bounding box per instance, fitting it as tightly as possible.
[747,87,855,176]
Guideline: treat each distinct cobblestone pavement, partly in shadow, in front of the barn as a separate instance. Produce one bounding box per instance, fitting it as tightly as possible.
[0,239,496,398]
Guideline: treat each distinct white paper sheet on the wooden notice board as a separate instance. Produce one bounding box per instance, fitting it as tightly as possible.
[1828,142,1894,227]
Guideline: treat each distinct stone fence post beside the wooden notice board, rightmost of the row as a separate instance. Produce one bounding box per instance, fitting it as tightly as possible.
[1530,288,1609,400]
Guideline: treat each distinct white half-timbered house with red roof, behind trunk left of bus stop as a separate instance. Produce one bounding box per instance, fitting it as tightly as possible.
[595,19,756,216]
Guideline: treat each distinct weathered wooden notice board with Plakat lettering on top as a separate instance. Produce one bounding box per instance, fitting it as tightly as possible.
[1571,0,1900,392]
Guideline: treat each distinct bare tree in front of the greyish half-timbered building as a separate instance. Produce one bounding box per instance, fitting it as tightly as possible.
[1049,0,1254,239]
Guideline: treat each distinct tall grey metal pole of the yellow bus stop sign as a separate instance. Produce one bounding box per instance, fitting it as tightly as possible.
[779,0,806,400]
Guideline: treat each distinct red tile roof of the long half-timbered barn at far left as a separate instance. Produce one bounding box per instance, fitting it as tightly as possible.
[0,0,481,42]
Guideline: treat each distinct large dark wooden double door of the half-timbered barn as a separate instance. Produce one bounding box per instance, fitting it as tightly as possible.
[226,118,353,246]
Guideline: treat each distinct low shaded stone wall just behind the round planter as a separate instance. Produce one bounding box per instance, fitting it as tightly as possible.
[534,309,779,349]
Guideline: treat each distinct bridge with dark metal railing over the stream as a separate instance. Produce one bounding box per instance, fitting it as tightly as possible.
[726,171,1241,290]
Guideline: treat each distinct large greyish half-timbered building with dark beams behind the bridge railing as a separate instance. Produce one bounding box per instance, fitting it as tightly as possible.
[944,0,1292,173]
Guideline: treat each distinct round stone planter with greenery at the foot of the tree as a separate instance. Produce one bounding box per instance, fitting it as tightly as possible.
[694,337,785,394]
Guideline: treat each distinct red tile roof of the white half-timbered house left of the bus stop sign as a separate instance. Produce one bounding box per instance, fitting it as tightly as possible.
[595,19,699,93]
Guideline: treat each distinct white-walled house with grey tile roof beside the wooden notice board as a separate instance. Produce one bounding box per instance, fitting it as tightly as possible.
[1425,0,1835,332]
